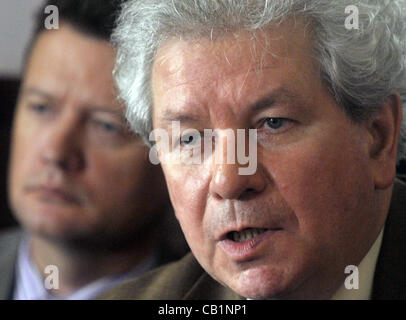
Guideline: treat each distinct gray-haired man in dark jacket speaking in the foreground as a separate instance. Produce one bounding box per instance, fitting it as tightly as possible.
[100,0,406,299]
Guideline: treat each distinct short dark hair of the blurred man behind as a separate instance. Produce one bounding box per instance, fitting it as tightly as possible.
[33,0,123,41]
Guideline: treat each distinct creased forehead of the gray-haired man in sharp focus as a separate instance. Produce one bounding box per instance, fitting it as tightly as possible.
[152,23,316,124]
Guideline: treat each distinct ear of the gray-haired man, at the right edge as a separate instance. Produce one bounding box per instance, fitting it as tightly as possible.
[368,94,402,189]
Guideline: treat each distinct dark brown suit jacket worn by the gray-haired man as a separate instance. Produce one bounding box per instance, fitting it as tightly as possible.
[99,181,406,300]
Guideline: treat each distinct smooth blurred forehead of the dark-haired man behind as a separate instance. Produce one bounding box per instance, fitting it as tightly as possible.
[23,26,117,111]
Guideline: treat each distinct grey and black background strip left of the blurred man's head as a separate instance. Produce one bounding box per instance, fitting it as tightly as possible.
[0,0,43,228]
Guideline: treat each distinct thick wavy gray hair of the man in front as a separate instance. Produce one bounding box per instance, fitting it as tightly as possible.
[112,0,406,160]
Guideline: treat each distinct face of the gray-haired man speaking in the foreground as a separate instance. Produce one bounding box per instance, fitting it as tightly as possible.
[152,25,382,298]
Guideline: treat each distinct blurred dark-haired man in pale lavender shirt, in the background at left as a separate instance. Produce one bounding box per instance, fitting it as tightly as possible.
[0,0,185,299]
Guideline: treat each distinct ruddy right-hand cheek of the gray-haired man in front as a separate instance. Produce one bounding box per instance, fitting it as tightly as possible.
[268,129,371,240]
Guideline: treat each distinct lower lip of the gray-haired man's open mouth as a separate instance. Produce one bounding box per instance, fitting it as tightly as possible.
[219,229,281,261]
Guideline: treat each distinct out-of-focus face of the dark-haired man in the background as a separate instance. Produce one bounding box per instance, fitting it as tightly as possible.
[9,25,166,245]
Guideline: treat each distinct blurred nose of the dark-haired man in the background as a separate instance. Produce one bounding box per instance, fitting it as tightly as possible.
[40,124,83,171]
